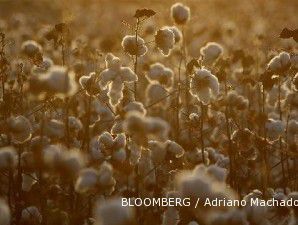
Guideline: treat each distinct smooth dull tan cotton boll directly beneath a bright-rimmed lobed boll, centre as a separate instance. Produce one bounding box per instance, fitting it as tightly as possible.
[146,83,169,108]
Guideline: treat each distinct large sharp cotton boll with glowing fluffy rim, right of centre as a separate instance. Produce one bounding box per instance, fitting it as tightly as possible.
[190,69,219,104]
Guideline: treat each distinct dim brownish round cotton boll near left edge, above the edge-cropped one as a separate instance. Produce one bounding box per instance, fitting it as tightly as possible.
[8,116,32,144]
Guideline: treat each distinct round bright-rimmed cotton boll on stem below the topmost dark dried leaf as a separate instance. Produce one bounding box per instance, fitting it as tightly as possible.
[121,35,147,56]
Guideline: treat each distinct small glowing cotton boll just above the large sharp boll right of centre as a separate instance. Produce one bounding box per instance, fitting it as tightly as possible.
[200,42,223,65]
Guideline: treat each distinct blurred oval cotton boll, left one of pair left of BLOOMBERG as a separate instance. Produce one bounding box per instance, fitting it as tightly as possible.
[75,168,99,194]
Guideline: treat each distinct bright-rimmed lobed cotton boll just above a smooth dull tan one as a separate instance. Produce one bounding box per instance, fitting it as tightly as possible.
[147,63,174,87]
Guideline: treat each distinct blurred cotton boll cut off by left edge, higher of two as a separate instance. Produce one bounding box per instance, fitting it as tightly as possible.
[0,146,18,170]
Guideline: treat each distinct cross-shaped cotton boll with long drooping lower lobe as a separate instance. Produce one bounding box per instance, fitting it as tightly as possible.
[99,53,138,106]
